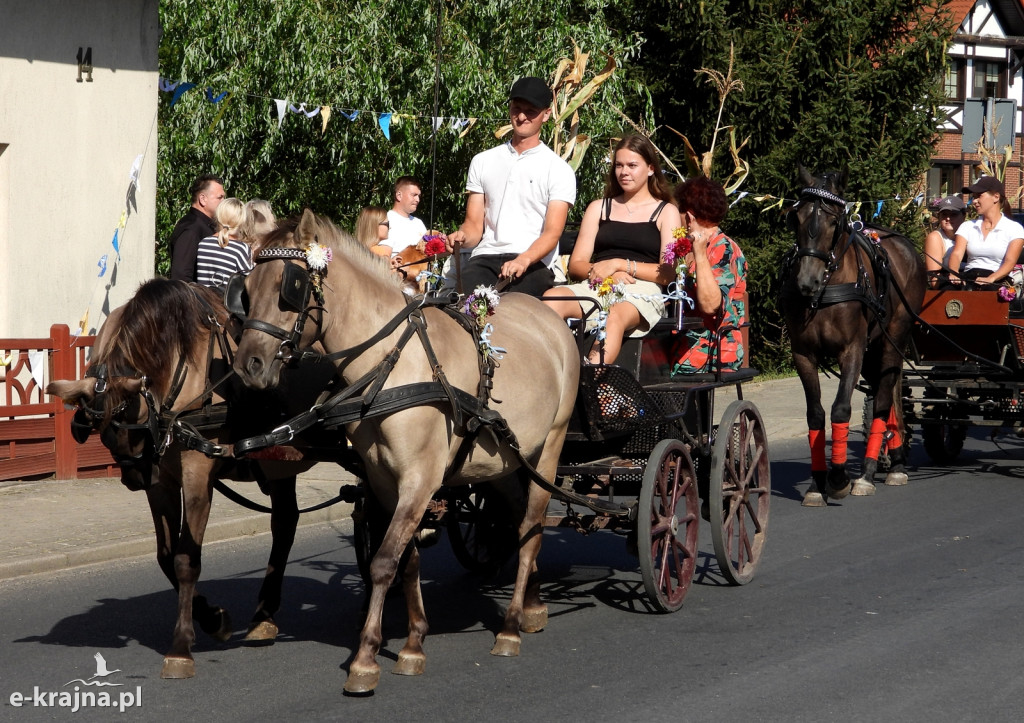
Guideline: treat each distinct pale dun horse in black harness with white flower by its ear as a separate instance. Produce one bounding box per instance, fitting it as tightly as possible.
[234,210,580,693]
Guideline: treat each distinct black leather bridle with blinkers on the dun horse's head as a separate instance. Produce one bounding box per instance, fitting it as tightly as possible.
[224,247,324,364]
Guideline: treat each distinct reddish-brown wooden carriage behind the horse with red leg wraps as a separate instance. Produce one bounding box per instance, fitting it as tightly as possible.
[902,288,1024,465]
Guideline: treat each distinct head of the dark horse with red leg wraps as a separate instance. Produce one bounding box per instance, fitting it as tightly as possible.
[787,166,847,298]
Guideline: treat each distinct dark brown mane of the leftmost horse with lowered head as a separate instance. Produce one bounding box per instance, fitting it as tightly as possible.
[92,279,220,414]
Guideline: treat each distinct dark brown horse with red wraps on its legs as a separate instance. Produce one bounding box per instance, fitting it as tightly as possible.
[782,168,926,507]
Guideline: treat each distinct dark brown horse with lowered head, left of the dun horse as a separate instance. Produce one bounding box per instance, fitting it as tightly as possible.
[47,279,319,678]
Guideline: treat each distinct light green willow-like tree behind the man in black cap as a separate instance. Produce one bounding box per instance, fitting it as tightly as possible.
[157,0,646,272]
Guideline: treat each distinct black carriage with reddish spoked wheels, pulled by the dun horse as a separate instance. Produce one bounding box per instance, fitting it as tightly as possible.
[378,298,771,612]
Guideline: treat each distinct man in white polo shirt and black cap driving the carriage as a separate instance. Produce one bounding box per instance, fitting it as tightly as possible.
[447,77,575,297]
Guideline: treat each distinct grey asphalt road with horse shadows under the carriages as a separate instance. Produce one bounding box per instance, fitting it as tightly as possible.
[0,432,1024,722]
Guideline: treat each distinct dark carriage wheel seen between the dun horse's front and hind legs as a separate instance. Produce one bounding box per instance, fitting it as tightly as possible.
[444,484,519,576]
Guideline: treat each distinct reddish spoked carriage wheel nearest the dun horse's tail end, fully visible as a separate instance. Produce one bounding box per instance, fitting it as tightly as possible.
[637,439,699,612]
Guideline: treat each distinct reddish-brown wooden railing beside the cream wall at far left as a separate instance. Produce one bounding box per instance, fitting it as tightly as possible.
[0,324,119,480]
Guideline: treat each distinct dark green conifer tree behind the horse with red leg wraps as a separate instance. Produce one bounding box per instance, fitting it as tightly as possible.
[615,0,955,369]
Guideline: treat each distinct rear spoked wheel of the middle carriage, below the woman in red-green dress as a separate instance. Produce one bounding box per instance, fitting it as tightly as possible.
[708,399,771,585]
